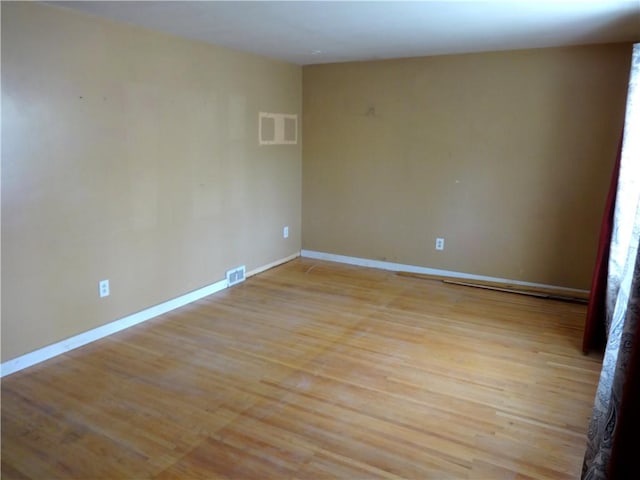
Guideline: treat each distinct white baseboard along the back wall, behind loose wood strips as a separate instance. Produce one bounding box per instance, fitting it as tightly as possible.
[300,250,589,294]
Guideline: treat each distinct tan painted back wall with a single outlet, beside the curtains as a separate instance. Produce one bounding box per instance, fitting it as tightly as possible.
[302,45,631,289]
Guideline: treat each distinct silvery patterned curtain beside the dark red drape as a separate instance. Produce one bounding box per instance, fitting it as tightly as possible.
[582,44,640,480]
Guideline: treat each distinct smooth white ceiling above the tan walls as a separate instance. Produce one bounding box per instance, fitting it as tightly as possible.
[50,0,640,65]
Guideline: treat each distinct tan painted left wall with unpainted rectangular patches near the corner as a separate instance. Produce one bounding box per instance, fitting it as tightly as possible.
[2,2,302,361]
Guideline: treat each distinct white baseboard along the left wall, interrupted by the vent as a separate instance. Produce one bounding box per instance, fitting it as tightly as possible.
[0,252,300,378]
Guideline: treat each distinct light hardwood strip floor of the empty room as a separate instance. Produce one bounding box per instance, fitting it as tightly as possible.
[2,259,601,480]
